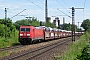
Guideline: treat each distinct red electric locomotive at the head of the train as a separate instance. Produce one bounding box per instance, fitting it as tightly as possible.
[19,26,44,45]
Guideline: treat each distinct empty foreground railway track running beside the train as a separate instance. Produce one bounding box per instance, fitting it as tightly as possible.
[7,38,71,60]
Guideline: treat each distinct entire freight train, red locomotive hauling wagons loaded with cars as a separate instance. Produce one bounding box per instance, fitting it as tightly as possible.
[19,26,82,45]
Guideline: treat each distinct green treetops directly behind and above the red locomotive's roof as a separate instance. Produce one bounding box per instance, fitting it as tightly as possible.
[13,17,40,29]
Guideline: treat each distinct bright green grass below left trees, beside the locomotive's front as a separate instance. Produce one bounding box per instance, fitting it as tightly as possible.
[0,32,19,48]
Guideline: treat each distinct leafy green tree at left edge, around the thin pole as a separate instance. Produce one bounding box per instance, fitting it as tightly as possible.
[0,18,16,37]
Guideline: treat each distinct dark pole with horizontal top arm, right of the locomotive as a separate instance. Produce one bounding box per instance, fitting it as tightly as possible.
[70,7,84,41]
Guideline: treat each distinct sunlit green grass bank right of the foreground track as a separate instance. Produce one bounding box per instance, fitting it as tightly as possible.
[54,33,90,60]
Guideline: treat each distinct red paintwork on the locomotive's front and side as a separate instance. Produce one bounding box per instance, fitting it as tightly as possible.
[19,26,44,39]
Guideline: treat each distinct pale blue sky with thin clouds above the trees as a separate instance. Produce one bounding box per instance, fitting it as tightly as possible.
[0,0,90,25]
